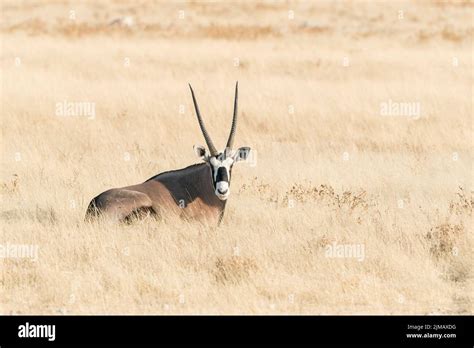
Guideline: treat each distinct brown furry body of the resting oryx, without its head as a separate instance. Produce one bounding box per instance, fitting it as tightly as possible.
[86,163,225,224]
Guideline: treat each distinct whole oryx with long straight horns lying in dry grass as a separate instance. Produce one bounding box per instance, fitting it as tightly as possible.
[86,82,250,224]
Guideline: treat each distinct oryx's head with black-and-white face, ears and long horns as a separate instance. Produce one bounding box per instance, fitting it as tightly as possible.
[189,82,250,201]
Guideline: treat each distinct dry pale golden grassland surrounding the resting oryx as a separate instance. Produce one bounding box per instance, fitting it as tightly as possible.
[0,1,474,314]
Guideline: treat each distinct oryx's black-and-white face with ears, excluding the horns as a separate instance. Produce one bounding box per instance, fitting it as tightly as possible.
[194,146,250,201]
